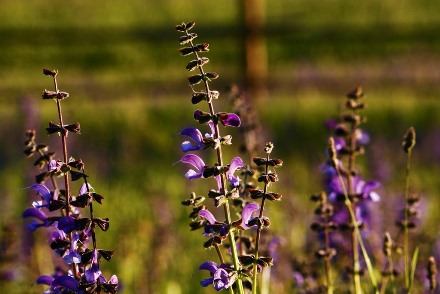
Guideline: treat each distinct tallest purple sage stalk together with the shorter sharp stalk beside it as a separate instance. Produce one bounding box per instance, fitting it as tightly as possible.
[175,22,282,293]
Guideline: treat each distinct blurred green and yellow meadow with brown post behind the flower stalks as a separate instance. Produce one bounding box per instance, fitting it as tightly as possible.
[0,0,440,293]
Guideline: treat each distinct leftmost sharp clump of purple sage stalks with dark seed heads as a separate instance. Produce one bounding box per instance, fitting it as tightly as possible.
[23,70,119,294]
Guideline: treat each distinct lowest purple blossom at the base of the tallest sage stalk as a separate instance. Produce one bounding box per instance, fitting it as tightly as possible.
[199,261,235,291]
